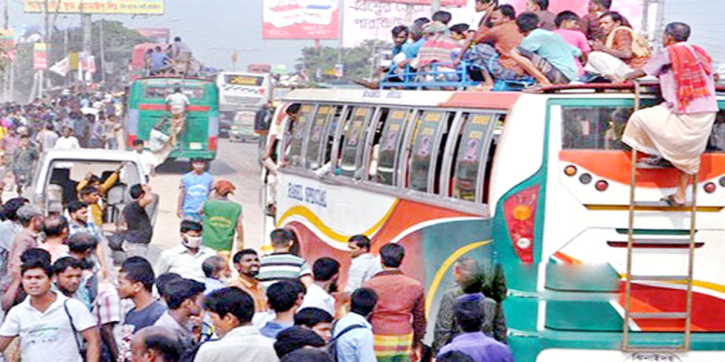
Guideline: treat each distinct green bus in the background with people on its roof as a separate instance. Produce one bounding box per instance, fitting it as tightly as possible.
[124,77,219,161]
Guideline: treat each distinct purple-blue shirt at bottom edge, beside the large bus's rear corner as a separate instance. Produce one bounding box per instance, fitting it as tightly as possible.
[438,332,514,362]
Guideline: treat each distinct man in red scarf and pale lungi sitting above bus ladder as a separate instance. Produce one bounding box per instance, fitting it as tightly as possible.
[622,23,719,206]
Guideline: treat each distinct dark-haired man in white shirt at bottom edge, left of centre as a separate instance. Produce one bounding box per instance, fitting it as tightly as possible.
[194,288,279,362]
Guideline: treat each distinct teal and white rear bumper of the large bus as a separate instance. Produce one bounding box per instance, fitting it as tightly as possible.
[507,330,725,362]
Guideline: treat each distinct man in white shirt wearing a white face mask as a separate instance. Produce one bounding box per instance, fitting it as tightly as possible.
[156,220,217,283]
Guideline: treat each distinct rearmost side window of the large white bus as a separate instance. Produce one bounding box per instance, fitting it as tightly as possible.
[451,113,499,202]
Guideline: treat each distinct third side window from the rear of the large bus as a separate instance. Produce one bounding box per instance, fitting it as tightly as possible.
[371,109,408,185]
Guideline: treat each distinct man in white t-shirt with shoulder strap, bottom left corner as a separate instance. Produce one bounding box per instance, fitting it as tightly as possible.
[0,260,101,362]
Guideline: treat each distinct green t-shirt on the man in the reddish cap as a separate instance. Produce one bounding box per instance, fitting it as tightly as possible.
[202,200,242,251]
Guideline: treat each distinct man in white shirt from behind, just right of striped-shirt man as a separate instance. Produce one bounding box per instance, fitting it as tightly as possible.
[300,258,340,316]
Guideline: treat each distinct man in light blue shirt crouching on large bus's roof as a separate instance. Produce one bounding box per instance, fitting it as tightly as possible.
[511,13,581,86]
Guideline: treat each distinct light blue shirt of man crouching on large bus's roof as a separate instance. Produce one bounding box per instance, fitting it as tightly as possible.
[521,29,582,80]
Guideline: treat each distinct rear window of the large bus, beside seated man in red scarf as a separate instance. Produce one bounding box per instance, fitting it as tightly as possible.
[562,106,633,150]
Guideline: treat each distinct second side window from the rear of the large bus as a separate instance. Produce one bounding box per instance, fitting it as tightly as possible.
[408,111,453,192]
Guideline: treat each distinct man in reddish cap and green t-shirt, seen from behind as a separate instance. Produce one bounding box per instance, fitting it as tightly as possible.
[202,180,244,260]
